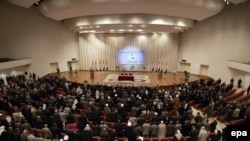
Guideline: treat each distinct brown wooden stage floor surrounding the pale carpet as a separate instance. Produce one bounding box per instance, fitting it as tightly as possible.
[49,71,204,87]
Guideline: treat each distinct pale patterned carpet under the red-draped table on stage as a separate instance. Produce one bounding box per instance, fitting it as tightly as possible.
[103,74,150,83]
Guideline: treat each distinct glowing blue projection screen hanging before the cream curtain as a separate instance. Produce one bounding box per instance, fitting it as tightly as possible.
[118,50,145,65]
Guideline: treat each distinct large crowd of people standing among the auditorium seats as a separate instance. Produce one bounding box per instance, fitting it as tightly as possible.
[0,74,250,141]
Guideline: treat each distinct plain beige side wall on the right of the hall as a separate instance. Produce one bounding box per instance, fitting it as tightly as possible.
[178,1,250,87]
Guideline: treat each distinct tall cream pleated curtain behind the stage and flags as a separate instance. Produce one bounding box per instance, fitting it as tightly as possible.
[79,33,178,71]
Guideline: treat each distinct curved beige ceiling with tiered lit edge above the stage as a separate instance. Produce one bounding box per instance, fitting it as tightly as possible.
[7,0,246,33]
